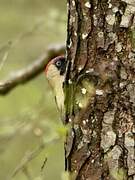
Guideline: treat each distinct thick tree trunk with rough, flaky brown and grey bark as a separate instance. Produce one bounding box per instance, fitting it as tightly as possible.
[64,0,135,180]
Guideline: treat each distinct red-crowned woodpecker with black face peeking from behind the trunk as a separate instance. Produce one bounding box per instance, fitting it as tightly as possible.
[45,56,66,118]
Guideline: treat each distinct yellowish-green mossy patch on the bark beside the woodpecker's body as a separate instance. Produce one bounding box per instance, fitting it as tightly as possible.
[64,75,95,115]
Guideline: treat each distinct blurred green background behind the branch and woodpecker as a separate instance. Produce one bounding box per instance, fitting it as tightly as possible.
[0,0,66,180]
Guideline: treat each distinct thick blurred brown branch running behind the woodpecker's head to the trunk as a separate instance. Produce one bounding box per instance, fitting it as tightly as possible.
[0,44,65,95]
